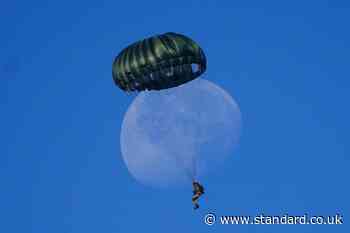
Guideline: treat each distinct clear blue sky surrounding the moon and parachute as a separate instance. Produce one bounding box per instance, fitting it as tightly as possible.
[0,0,350,233]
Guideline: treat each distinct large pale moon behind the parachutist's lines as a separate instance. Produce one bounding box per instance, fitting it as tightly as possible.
[120,78,241,187]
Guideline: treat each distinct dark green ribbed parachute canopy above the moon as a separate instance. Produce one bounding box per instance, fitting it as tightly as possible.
[112,32,206,91]
